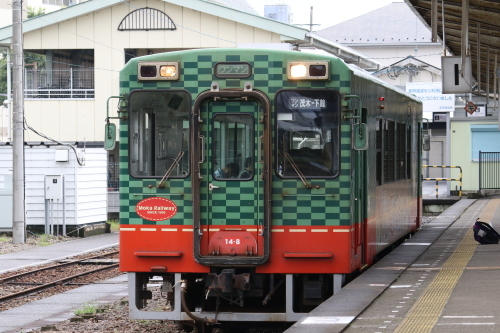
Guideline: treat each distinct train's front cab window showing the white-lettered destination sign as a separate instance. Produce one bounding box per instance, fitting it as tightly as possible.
[276,89,340,178]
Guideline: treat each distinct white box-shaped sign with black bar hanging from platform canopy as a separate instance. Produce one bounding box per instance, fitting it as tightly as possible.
[441,56,474,94]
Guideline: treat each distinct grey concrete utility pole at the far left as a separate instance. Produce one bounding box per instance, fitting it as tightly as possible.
[12,0,26,244]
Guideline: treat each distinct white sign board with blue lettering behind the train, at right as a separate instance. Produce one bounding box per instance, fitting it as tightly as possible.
[406,82,455,112]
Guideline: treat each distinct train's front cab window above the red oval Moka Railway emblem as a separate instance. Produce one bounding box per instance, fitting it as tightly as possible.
[129,90,191,178]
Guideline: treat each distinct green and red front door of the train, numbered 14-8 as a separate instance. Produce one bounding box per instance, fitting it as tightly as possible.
[191,91,268,264]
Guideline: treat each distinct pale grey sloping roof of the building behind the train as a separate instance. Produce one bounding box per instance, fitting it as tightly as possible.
[316,2,431,45]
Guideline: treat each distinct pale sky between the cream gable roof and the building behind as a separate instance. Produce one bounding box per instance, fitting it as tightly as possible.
[247,0,403,30]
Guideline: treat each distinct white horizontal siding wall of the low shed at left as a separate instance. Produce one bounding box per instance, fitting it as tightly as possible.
[0,145,107,225]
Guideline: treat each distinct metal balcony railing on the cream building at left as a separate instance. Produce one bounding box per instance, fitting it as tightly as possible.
[24,69,95,99]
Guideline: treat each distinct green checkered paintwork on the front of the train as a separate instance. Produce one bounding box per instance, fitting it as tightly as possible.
[120,49,352,226]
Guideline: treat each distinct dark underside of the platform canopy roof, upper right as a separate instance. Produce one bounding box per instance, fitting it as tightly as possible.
[405,0,500,93]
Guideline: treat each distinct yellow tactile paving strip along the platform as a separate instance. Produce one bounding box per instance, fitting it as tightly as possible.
[394,199,500,333]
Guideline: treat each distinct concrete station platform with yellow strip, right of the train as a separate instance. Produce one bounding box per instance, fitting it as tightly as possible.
[286,196,500,333]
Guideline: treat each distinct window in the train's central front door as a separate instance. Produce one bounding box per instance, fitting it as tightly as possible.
[212,113,255,180]
